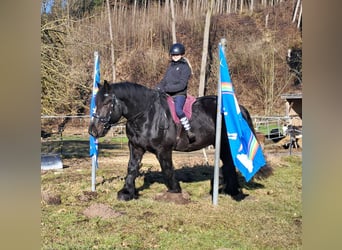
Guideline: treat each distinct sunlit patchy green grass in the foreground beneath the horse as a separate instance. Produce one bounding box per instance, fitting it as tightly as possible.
[41,156,302,249]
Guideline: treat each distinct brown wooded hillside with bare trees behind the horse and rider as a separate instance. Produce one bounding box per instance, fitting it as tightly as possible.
[41,0,302,115]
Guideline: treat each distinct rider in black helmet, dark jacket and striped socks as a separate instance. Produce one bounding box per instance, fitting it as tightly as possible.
[156,43,195,142]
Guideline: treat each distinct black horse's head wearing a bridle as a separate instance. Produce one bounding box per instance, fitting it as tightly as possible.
[88,80,122,138]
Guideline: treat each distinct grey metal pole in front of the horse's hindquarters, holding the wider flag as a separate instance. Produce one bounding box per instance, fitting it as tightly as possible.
[213,38,227,206]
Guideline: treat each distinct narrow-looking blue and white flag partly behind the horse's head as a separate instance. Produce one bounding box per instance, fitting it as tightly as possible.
[89,51,100,167]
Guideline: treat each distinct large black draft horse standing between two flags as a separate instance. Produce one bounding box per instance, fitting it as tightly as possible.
[89,81,262,201]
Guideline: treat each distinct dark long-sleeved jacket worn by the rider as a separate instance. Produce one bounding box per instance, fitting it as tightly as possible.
[157,58,191,96]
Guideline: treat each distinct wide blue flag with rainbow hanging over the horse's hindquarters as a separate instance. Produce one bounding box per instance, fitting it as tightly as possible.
[219,45,266,181]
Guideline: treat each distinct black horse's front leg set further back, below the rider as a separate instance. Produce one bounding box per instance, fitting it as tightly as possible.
[156,150,182,193]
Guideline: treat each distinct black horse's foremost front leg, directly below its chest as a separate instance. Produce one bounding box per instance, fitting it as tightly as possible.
[118,142,145,201]
